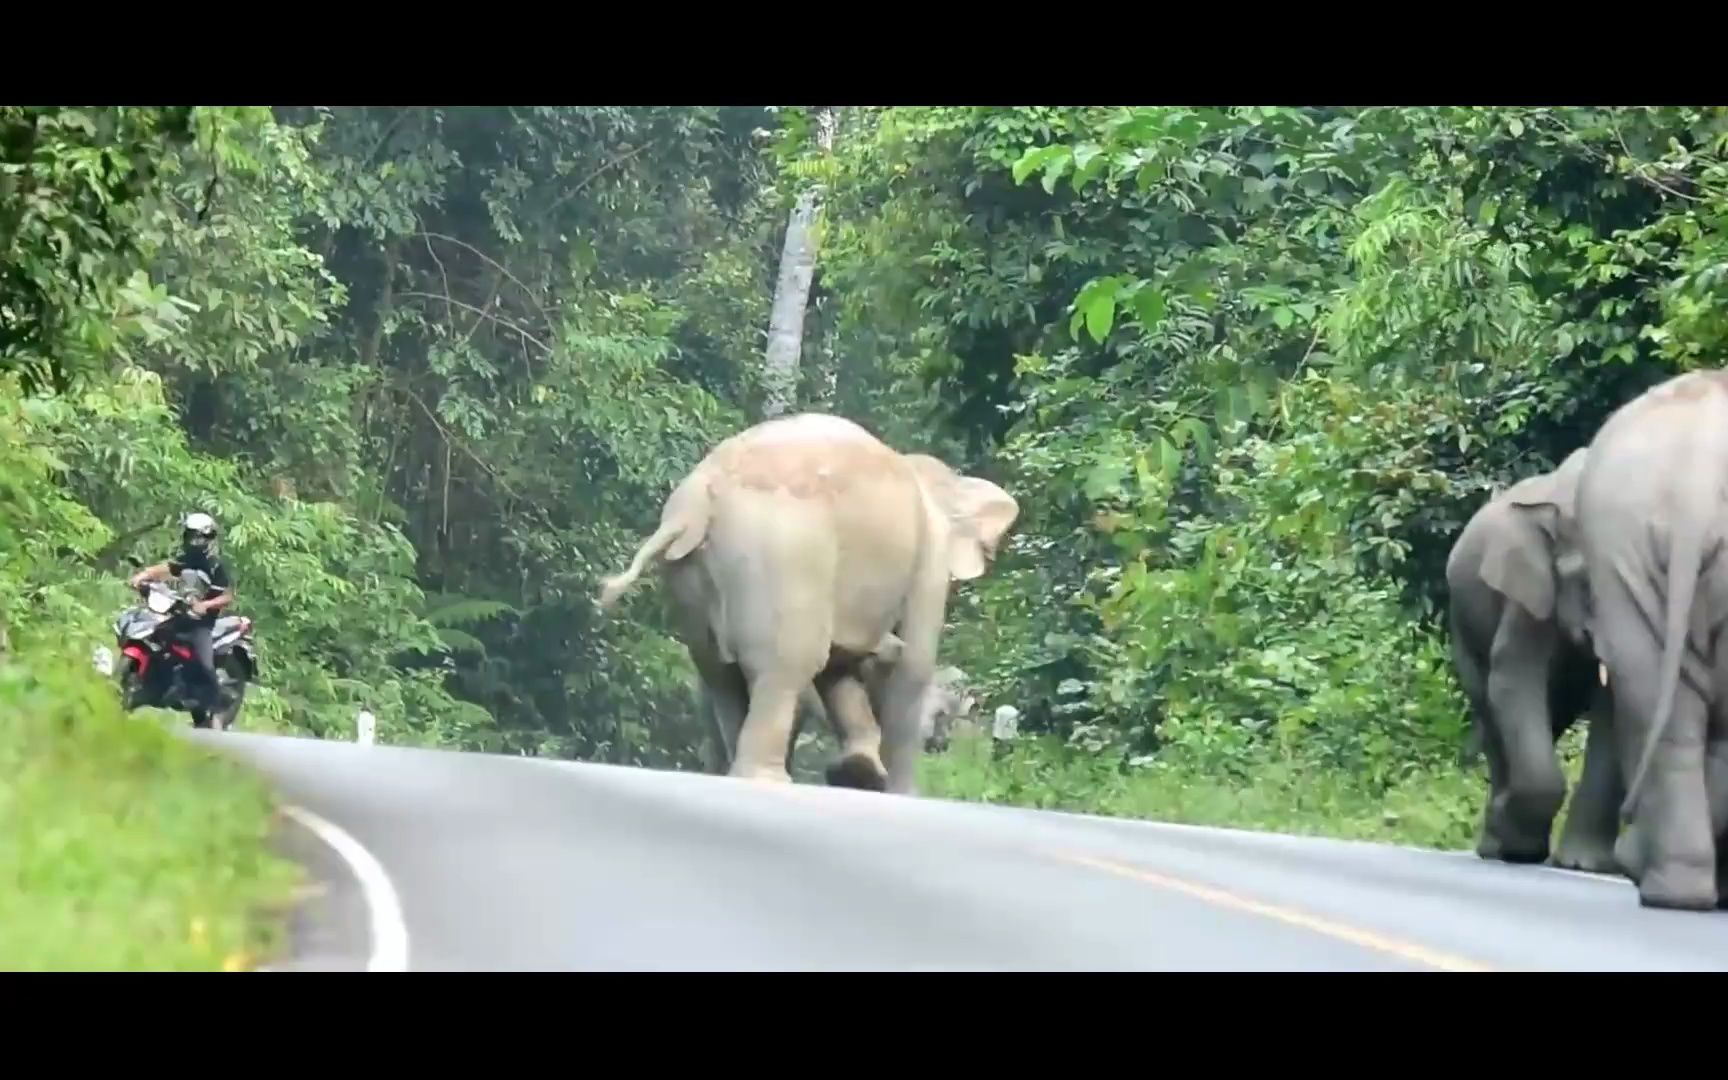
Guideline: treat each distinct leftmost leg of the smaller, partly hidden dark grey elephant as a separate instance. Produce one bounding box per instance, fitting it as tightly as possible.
[1484,607,1566,862]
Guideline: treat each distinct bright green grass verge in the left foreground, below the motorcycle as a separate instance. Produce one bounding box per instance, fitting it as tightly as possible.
[0,639,299,971]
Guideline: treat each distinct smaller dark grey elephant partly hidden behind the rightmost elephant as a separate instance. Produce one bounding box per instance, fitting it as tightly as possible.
[1446,449,1621,873]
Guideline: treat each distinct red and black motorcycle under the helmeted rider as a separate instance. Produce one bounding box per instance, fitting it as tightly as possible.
[95,567,257,731]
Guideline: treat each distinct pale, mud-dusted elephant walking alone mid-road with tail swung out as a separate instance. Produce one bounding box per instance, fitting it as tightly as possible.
[600,413,1020,795]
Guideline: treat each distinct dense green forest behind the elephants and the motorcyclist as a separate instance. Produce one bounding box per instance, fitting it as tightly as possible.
[0,105,1728,884]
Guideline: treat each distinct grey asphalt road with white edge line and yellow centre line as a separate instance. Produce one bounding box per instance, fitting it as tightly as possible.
[192,733,1728,971]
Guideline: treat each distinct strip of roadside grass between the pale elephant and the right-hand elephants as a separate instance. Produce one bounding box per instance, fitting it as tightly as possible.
[919,731,1583,850]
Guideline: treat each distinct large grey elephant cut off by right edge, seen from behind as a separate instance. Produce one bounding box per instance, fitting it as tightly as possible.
[1578,372,1728,911]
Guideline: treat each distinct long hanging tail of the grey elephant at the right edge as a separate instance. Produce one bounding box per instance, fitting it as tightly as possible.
[1621,387,1728,821]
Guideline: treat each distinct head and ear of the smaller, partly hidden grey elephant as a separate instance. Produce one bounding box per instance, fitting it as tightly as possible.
[1481,449,1590,645]
